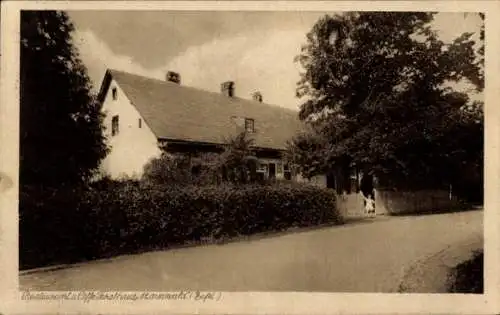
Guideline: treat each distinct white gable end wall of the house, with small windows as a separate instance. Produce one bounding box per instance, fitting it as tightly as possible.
[101,80,161,178]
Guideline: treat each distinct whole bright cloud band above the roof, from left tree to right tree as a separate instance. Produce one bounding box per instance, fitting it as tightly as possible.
[74,30,305,109]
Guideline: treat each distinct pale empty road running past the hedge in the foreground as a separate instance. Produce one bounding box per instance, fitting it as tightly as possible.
[20,210,483,293]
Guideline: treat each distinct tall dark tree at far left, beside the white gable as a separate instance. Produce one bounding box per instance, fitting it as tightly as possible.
[20,11,107,187]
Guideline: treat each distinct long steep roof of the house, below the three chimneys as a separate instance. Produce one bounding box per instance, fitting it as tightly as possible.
[100,70,301,149]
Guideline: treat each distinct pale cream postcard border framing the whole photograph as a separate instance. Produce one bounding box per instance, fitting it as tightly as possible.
[0,1,500,314]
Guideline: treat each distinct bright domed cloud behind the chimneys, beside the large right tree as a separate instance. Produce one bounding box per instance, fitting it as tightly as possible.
[165,31,305,108]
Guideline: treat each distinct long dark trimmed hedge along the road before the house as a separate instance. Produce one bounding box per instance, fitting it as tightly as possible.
[20,181,342,269]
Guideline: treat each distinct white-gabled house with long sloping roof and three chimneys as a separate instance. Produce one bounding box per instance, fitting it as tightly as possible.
[95,70,314,182]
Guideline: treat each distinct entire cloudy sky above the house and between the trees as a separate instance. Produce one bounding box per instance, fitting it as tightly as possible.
[68,11,481,109]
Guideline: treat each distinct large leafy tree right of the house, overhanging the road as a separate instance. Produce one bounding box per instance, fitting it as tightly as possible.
[291,12,482,190]
